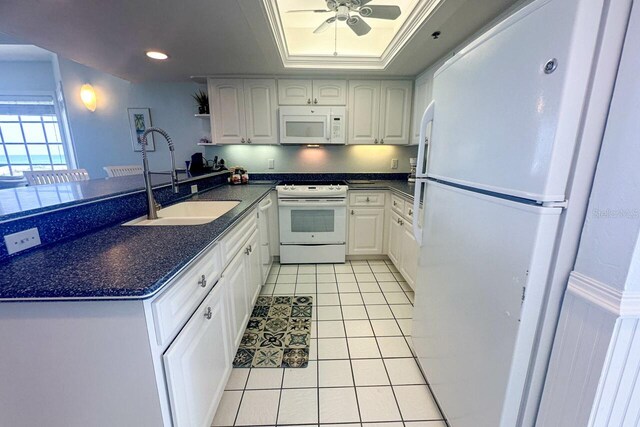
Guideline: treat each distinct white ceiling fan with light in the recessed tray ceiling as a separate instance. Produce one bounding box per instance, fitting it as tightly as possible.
[287,0,401,36]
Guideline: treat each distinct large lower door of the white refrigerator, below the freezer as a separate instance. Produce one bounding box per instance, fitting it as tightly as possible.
[413,181,561,427]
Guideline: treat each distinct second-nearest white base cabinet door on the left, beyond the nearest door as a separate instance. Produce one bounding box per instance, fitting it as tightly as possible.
[222,248,250,350]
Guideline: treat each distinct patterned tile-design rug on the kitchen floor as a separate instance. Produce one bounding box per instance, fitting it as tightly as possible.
[233,296,313,368]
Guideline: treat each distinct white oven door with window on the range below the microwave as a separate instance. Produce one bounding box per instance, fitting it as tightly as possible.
[278,199,347,245]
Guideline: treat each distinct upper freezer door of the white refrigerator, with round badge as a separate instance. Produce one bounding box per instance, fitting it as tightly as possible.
[428,0,601,201]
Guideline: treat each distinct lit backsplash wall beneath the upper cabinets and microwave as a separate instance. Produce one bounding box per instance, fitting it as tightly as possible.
[205,145,418,173]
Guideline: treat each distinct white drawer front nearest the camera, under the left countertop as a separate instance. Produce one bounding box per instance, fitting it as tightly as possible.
[151,244,222,346]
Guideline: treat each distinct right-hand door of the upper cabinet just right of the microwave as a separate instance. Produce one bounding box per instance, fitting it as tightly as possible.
[379,80,413,145]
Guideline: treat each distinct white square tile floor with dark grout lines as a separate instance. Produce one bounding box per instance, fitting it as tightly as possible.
[213,260,446,427]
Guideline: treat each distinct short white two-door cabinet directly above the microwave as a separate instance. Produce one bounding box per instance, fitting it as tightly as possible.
[278,79,347,105]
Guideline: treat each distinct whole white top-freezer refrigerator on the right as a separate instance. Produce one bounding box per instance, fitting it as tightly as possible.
[412,0,601,427]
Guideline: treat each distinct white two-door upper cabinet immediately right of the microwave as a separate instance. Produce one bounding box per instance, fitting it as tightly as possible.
[348,80,413,145]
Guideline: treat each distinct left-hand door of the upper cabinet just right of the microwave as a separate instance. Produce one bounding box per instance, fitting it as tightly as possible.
[348,80,380,144]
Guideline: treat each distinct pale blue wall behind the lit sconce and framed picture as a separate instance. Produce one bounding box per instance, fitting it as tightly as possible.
[59,58,208,178]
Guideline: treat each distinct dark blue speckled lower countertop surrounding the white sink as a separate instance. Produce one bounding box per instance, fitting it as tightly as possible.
[0,185,273,301]
